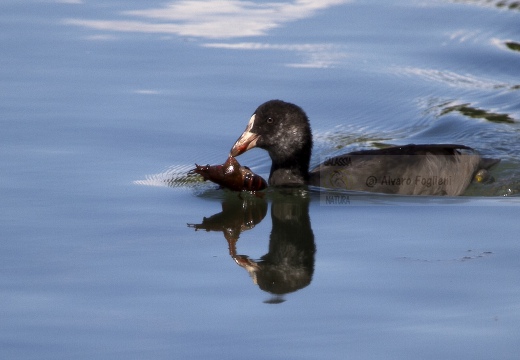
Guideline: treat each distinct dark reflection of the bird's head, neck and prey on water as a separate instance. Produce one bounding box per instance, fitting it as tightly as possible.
[188,193,316,304]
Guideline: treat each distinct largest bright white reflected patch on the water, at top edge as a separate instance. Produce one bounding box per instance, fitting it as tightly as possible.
[64,0,349,39]
